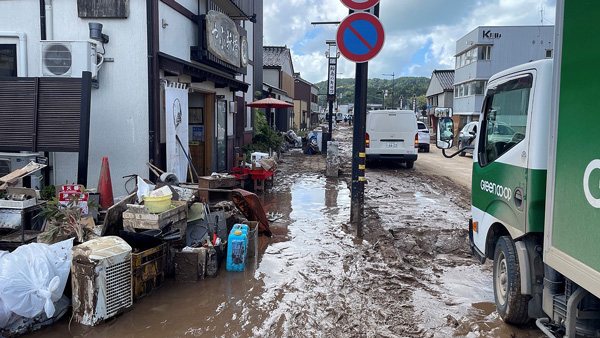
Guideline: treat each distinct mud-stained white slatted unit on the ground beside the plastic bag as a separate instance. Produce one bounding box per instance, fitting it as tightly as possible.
[71,236,133,326]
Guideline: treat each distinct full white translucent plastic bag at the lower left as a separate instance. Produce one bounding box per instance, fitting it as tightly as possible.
[0,238,73,318]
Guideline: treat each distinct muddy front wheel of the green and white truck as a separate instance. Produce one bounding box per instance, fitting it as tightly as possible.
[494,236,531,324]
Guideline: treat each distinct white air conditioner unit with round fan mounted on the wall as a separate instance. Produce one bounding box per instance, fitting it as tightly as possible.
[40,40,98,79]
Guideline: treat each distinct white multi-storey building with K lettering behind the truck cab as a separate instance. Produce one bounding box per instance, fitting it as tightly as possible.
[453,26,554,128]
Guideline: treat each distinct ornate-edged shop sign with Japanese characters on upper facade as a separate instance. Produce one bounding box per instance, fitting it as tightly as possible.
[206,11,240,67]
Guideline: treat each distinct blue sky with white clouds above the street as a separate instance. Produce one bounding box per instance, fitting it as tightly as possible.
[263,0,556,83]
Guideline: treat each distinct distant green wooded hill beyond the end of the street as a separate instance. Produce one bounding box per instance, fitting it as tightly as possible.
[315,77,429,107]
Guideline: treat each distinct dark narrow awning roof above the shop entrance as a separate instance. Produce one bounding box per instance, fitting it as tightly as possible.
[158,52,250,93]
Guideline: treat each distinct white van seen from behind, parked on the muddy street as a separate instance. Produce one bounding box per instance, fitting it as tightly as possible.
[366,110,419,168]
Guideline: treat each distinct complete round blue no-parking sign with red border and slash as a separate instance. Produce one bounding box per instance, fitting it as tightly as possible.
[336,12,385,63]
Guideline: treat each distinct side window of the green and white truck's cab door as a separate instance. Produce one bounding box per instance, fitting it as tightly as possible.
[478,75,533,167]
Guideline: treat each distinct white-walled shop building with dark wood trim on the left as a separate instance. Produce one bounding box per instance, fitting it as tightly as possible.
[0,0,263,195]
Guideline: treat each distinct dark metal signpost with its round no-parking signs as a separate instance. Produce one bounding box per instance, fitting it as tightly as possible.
[336,0,385,237]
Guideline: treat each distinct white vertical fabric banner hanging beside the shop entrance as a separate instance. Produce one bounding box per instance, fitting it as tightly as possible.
[165,83,189,182]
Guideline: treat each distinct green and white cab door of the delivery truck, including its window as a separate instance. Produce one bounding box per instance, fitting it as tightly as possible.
[472,71,535,252]
